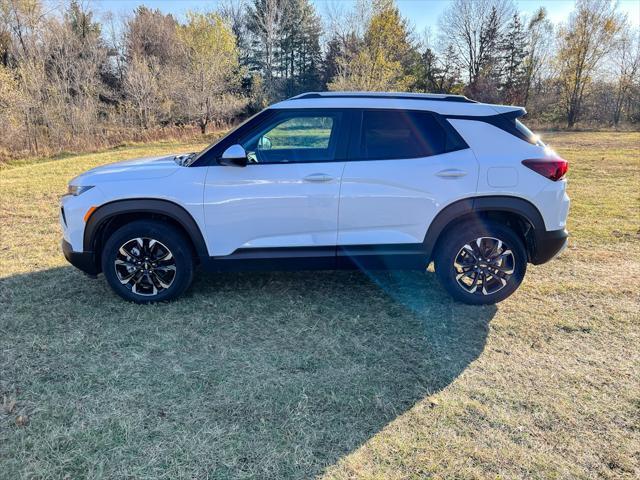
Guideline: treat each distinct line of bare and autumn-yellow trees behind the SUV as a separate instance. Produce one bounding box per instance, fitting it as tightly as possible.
[0,0,640,159]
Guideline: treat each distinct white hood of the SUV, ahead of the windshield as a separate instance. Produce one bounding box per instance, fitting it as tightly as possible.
[70,155,182,185]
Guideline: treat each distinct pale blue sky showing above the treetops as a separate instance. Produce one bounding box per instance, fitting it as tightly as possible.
[90,0,640,33]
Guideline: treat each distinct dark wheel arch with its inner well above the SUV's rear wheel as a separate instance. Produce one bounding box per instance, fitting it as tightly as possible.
[424,195,546,261]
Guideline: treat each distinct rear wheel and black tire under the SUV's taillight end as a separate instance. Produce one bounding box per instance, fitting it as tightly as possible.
[434,222,527,305]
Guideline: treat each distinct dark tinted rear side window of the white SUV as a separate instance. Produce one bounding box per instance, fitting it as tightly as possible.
[360,110,464,160]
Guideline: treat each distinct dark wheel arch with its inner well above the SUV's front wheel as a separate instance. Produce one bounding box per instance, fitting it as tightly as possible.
[83,198,208,268]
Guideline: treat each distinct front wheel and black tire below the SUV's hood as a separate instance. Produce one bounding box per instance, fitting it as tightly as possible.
[102,220,194,304]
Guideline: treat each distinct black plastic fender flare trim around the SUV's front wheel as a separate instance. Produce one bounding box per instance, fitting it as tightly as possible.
[83,198,209,258]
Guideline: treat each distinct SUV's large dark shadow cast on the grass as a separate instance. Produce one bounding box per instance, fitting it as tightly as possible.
[0,267,496,478]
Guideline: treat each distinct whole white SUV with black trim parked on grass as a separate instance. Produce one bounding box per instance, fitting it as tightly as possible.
[60,92,569,304]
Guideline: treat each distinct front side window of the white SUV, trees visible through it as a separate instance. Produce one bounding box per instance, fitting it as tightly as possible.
[241,112,341,163]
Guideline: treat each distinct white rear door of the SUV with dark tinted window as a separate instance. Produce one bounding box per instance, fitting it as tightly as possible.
[338,110,478,246]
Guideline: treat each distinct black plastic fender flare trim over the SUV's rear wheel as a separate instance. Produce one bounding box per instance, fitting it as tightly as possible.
[423,195,546,257]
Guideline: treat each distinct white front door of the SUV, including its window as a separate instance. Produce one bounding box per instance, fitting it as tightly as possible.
[204,109,347,256]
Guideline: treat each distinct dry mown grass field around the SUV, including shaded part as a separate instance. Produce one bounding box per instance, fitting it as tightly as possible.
[0,133,640,479]
